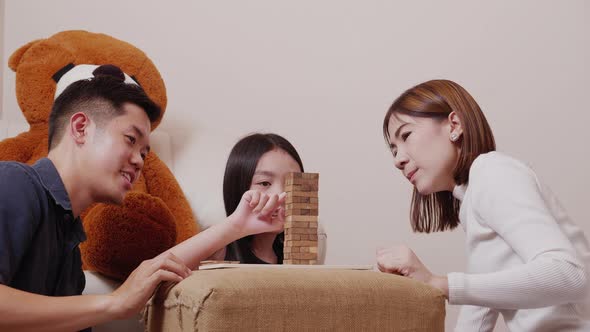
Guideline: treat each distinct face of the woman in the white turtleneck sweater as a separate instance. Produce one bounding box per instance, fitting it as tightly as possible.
[388,113,461,195]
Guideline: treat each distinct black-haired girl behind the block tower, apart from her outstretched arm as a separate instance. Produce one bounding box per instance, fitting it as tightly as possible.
[212,134,303,264]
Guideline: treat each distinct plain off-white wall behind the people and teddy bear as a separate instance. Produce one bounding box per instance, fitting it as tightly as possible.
[3,0,590,326]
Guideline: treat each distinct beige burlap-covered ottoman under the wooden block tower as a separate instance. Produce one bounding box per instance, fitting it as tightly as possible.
[144,268,445,332]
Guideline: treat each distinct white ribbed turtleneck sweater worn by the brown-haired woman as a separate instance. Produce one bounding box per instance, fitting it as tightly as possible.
[448,152,590,332]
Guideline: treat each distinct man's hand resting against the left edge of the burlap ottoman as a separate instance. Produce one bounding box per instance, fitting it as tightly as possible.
[111,252,192,319]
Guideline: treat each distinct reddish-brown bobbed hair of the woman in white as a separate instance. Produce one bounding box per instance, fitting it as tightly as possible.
[383,80,496,233]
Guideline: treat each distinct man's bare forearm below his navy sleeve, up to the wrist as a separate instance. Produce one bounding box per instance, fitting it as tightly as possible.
[0,285,117,331]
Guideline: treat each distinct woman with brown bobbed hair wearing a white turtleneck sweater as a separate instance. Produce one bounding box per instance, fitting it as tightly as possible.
[377,80,590,331]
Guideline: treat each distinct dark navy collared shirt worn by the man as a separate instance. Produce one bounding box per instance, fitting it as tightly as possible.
[0,158,86,296]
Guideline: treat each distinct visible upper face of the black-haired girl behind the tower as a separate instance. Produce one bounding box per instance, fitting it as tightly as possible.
[250,148,301,194]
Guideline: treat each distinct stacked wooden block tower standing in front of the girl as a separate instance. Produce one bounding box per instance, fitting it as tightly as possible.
[283,173,320,265]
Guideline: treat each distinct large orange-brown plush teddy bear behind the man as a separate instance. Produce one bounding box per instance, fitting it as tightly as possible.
[0,31,198,280]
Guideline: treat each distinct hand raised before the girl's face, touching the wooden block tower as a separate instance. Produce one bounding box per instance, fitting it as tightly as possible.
[229,190,287,236]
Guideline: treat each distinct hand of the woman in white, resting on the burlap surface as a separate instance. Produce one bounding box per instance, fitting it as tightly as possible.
[377,245,449,298]
